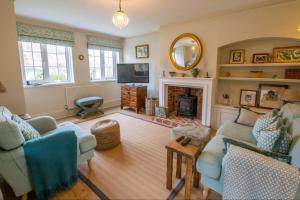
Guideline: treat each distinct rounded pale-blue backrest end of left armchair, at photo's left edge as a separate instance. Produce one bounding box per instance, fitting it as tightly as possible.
[0,121,25,151]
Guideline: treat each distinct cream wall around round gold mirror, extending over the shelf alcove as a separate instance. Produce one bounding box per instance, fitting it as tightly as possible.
[157,0,300,76]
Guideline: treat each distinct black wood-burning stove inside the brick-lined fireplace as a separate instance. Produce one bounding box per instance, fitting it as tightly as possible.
[177,88,198,119]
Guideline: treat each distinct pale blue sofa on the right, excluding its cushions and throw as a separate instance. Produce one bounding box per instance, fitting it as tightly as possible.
[196,104,300,199]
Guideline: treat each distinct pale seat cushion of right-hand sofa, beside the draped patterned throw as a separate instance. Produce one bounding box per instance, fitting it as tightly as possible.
[217,122,256,144]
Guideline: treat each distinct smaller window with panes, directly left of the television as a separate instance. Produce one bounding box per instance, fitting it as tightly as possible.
[89,49,120,80]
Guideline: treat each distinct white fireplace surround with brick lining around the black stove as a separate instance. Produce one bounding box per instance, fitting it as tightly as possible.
[159,77,214,126]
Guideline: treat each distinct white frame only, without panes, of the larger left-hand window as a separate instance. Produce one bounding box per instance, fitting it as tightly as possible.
[18,41,74,86]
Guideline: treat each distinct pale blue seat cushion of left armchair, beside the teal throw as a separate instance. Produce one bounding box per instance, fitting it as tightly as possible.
[56,122,96,153]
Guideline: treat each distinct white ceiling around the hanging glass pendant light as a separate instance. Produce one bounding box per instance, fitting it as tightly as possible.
[15,0,291,37]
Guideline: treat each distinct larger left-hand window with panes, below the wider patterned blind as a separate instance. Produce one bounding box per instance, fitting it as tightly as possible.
[19,42,73,84]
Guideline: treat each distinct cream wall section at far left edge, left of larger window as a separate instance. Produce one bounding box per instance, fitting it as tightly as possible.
[0,0,25,114]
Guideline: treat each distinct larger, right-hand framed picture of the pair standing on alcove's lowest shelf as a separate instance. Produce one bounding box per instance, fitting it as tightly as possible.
[258,84,288,109]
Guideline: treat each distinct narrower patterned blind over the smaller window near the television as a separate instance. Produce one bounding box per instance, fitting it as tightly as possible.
[87,36,123,51]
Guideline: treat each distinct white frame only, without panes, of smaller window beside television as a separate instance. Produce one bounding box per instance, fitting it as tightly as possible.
[88,48,121,82]
